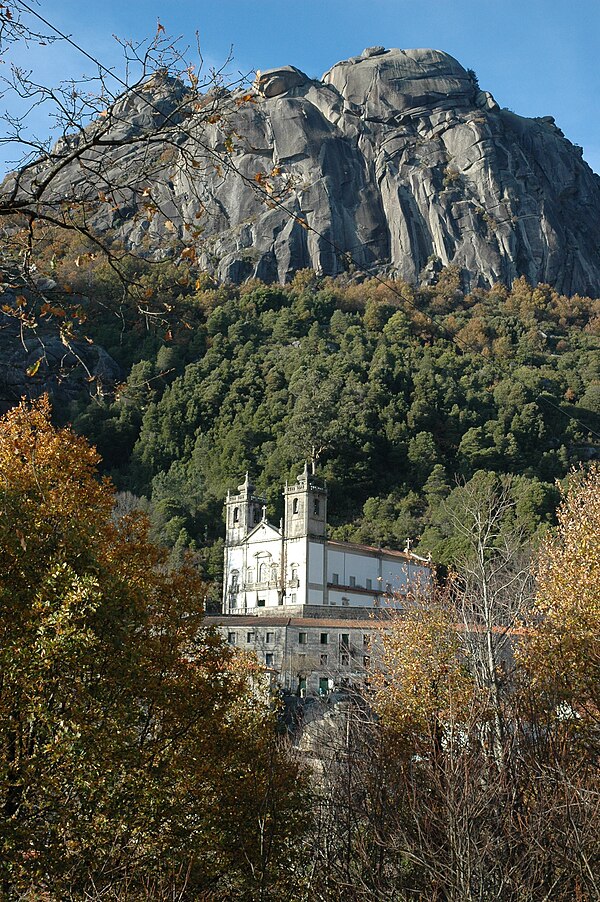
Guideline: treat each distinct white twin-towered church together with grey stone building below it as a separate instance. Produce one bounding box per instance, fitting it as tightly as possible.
[207,466,431,695]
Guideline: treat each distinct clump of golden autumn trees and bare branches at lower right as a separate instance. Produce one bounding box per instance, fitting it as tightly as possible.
[337,474,600,902]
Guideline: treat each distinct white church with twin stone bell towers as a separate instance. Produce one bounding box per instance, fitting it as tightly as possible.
[223,466,431,617]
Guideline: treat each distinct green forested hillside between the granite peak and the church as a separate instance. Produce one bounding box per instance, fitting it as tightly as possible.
[30,257,600,588]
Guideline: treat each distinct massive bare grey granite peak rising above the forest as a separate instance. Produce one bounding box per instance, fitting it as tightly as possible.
[8,47,600,295]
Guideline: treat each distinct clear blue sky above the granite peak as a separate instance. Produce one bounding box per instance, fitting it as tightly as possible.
[0,0,600,173]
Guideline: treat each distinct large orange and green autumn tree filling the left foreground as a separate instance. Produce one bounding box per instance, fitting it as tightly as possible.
[0,399,303,899]
